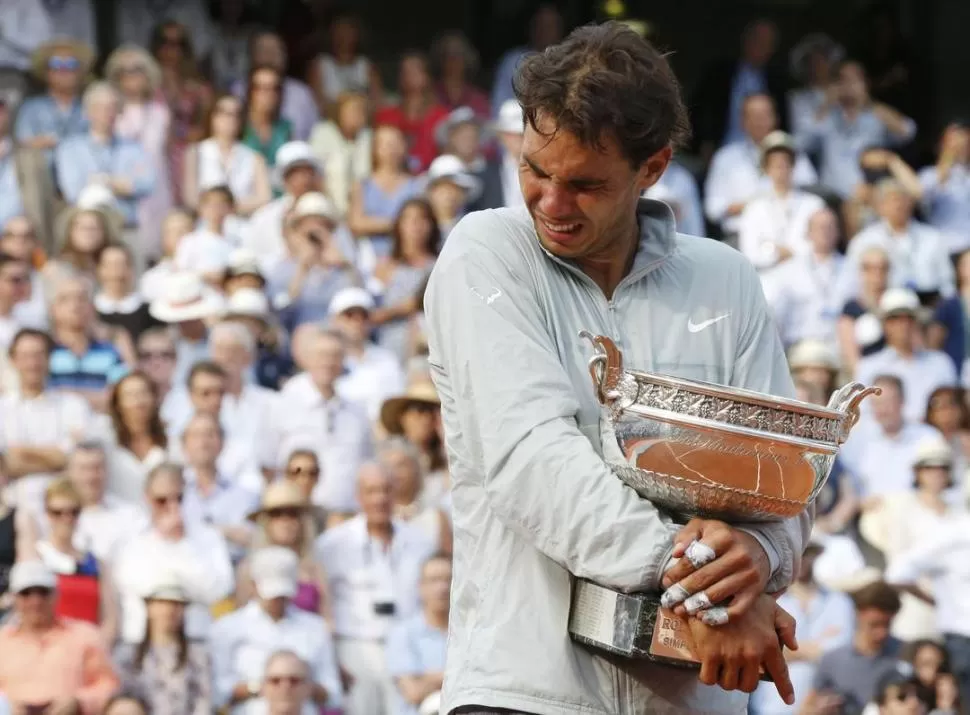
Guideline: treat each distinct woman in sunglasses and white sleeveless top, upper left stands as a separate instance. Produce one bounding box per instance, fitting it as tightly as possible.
[182,94,273,216]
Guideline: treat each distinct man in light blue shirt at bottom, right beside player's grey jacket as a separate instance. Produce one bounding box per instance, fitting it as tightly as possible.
[387,554,451,715]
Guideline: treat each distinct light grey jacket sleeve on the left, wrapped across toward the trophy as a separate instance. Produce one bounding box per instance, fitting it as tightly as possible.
[425,217,676,592]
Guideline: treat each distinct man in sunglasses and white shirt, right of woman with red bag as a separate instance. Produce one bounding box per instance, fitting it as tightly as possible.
[114,464,234,644]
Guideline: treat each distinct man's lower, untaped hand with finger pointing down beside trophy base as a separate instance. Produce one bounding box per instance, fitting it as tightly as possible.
[688,594,798,705]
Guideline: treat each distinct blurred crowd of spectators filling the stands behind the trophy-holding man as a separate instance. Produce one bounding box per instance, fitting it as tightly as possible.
[0,0,970,715]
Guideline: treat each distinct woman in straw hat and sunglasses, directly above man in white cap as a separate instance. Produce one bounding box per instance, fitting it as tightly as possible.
[236,480,330,618]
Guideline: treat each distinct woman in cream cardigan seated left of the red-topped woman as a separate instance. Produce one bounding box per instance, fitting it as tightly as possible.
[310,92,374,216]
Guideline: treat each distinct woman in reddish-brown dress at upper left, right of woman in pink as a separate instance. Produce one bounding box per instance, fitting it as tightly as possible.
[151,20,212,196]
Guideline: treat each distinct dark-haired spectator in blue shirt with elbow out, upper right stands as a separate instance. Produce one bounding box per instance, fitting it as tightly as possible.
[803,60,916,199]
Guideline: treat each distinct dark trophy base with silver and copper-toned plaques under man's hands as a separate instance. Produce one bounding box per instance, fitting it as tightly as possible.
[569,579,770,680]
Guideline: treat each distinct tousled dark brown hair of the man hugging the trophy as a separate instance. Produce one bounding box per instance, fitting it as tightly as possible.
[512,21,690,168]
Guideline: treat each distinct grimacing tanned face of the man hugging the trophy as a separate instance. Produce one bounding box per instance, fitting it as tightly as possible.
[519,115,670,262]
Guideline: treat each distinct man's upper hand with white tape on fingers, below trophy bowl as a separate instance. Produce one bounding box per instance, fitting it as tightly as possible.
[661,519,771,625]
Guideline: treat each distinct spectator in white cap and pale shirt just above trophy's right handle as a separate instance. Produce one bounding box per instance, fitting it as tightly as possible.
[855,288,959,422]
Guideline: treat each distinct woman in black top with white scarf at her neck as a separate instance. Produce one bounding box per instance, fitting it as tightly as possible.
[94,245,160,352]
